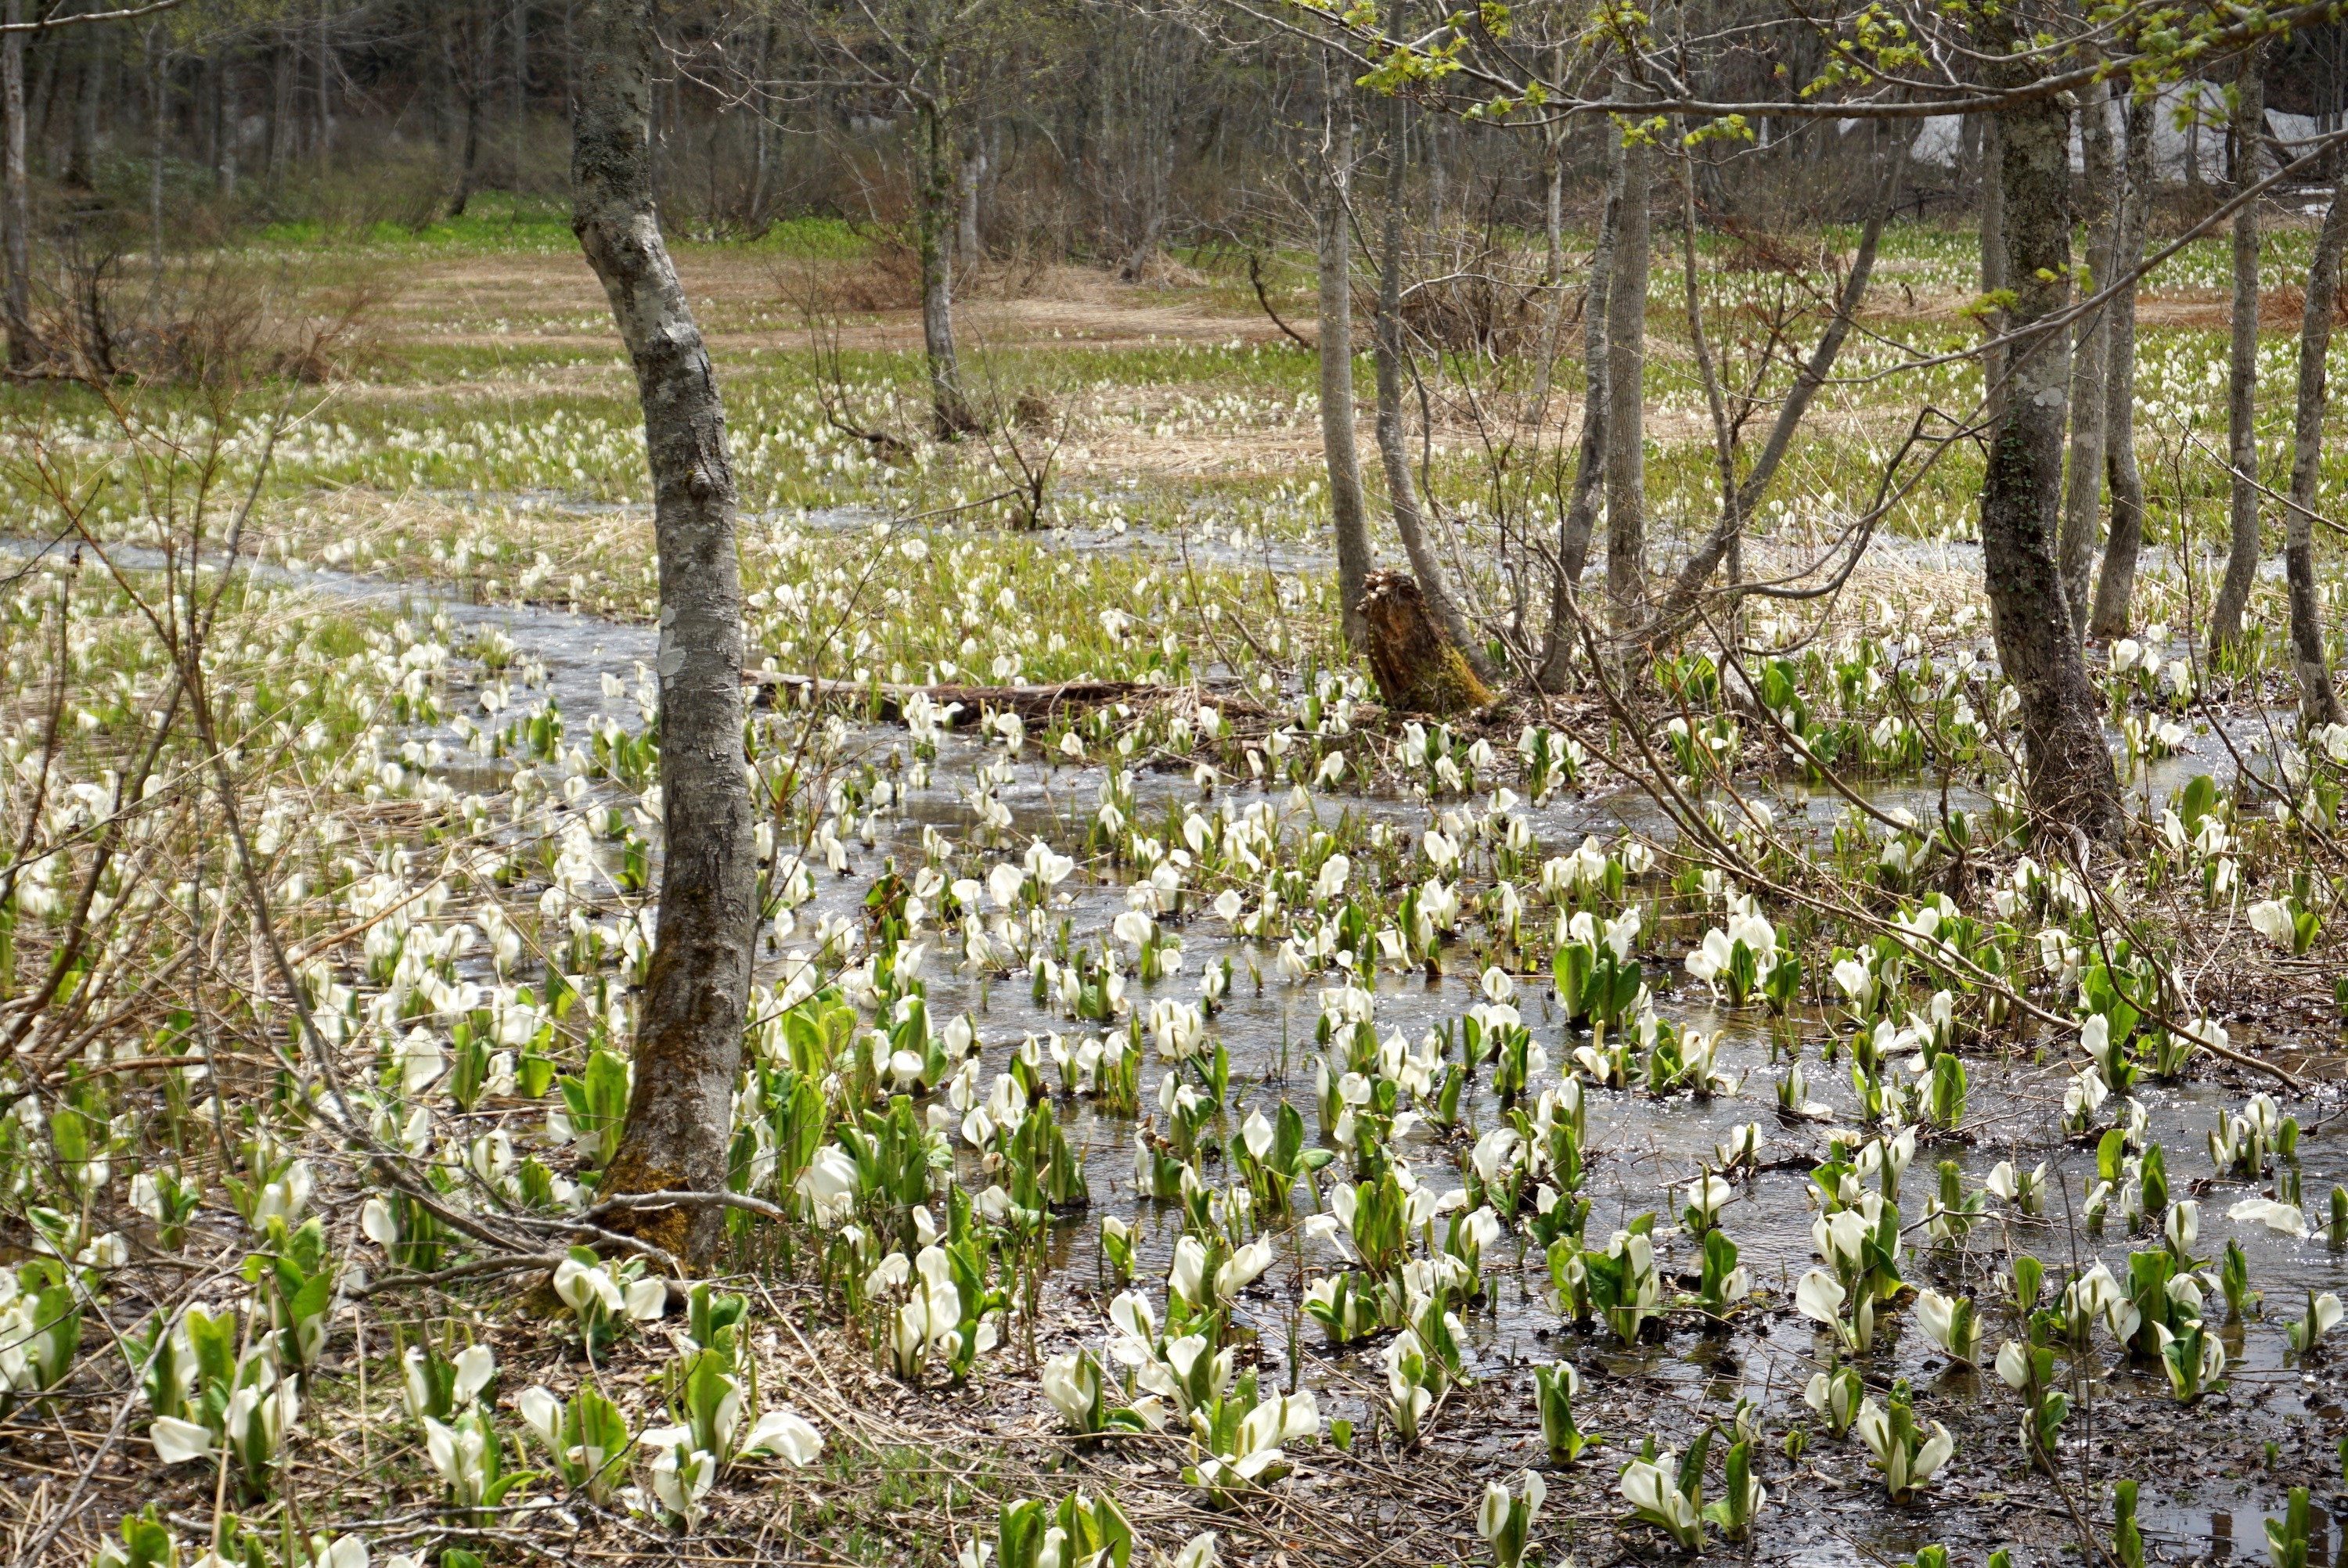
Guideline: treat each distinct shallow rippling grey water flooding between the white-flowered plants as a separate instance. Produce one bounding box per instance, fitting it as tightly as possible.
[23,530,2348,1568]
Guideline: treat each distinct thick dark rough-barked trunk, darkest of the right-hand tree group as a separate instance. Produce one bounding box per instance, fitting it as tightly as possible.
[1982,80,2120,838]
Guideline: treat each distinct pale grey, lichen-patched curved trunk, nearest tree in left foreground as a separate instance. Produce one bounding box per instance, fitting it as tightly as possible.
[571,0,758,1261]
